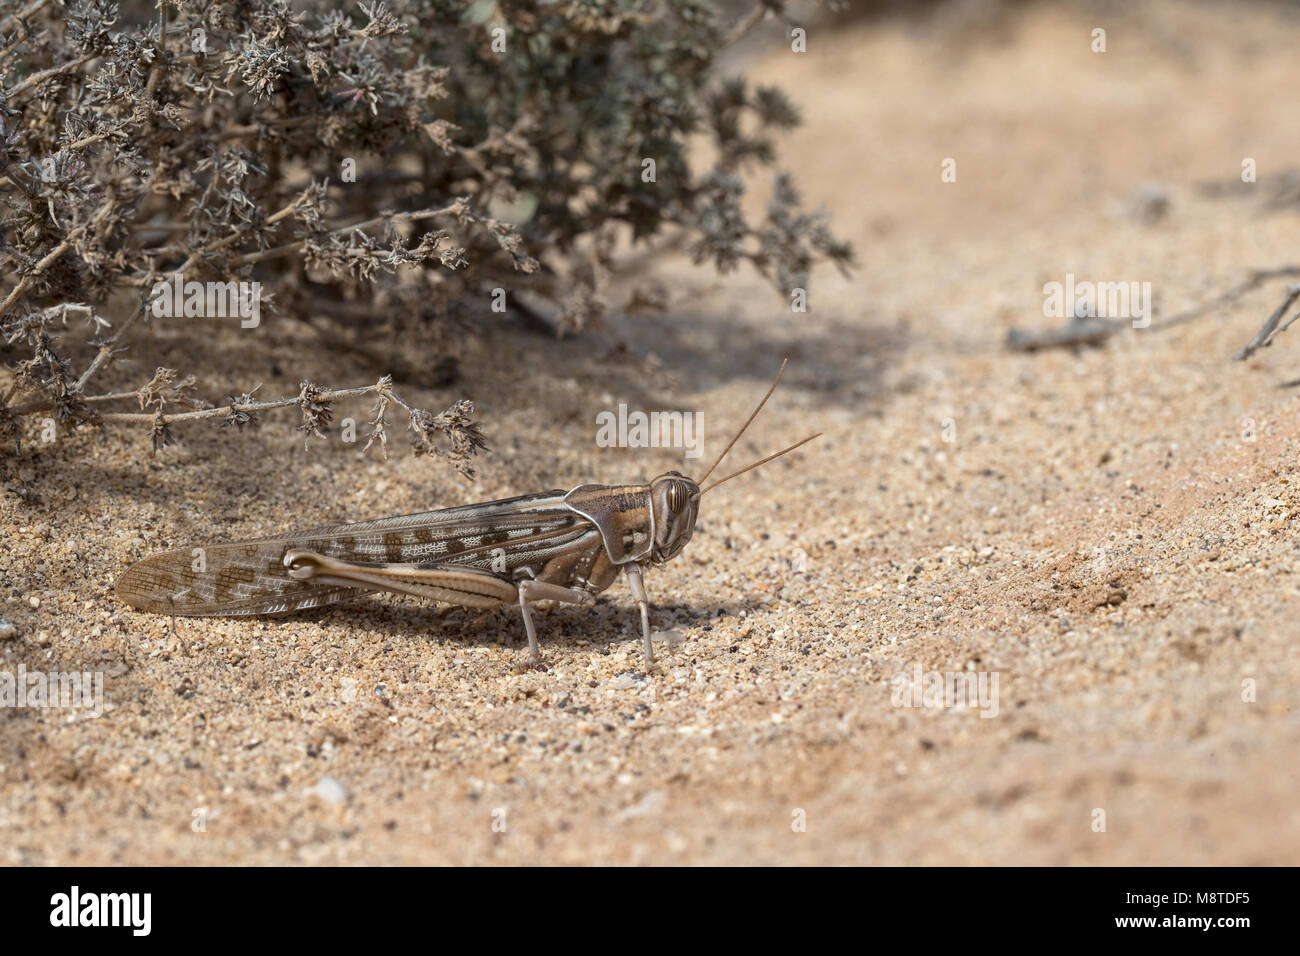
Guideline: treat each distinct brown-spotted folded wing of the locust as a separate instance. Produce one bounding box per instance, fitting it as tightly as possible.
[117,490,598,615]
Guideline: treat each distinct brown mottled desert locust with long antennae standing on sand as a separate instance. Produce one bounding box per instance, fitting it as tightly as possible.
[117,362,818,663]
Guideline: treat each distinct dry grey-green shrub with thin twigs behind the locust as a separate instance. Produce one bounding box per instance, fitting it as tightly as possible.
[0,0,853,476]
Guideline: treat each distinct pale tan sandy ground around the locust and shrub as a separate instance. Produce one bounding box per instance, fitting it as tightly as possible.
[0,5,1300,864]
